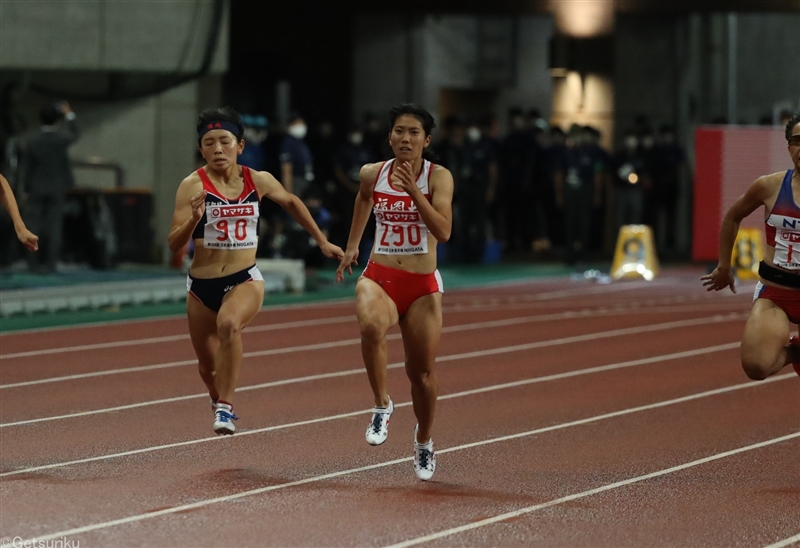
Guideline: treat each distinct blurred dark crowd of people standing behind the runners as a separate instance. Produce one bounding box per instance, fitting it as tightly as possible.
[245,108,685,269]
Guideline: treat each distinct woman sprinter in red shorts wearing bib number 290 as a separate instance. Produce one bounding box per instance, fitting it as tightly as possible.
[336,104,453,481]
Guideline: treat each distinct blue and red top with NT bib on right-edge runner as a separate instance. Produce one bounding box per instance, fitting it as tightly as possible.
[764,169,800,270]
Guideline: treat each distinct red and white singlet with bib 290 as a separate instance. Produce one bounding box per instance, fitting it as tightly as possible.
[372,159,433,255]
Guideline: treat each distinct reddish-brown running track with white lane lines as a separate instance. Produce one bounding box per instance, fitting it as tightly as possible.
[0,271,800,547]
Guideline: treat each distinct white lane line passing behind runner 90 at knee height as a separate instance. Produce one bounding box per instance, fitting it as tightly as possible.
[0,278,688,360]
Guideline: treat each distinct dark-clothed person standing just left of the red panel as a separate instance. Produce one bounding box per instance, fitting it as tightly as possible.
[652,125,685,251]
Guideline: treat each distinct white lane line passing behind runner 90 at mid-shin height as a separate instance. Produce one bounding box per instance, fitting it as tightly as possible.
[0,308,747,390]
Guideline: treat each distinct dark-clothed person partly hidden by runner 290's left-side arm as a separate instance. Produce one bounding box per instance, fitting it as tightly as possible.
[331,124,379,254]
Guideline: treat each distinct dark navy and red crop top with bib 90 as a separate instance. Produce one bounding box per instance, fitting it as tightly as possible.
[192,166,259,249]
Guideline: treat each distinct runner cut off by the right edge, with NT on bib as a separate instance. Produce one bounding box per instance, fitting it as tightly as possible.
[700,112,800,380]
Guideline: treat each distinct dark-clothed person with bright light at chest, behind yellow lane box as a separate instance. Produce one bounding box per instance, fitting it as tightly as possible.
[612,130,650,238]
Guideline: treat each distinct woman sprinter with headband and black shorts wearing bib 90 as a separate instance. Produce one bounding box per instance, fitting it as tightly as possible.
[168,108,344,434]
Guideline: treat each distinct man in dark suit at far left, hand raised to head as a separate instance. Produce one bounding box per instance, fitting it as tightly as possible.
[21,101,79,273]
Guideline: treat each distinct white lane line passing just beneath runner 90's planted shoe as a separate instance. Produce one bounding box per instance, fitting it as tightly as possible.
[0,342,740,478]
